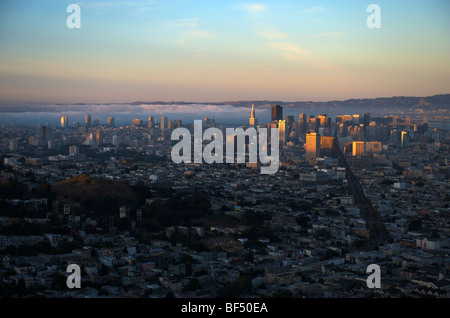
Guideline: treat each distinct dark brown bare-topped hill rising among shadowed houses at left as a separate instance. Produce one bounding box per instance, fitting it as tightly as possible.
[52,174,137,212]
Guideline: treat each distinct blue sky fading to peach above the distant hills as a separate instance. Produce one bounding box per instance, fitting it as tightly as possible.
[0,0,450,103]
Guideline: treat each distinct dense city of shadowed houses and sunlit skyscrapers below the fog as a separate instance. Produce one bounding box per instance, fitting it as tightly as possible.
[0,105,450,298]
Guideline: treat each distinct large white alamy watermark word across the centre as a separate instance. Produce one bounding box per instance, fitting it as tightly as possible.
[170,120,279,174]
